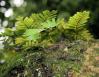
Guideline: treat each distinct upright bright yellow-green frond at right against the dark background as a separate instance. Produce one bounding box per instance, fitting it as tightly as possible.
[65,11,90,30]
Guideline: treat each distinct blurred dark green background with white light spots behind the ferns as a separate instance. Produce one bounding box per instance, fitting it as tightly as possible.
[0,0,99,38]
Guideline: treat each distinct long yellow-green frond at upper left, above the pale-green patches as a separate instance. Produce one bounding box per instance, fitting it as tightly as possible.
[16,10,57,30]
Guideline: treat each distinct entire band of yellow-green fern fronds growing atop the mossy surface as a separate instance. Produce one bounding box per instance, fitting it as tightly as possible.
[1,10,91,45]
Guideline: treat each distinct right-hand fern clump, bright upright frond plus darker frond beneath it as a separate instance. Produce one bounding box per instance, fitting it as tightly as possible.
[64,11,92,40]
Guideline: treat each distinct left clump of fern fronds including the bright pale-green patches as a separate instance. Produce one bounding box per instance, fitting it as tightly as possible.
[10,10,57,46]
